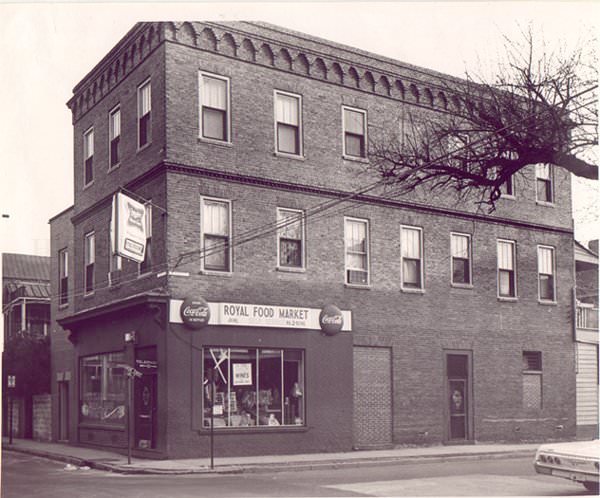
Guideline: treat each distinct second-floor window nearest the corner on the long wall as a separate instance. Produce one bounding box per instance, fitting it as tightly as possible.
[200,197,231,272]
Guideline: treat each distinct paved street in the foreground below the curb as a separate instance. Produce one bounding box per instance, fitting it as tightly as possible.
[2,452,587,498]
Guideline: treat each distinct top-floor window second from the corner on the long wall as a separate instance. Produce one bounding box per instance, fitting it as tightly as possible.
[275,91,302,156]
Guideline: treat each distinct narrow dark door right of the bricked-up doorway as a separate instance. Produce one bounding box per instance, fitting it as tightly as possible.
[445,352,472,442]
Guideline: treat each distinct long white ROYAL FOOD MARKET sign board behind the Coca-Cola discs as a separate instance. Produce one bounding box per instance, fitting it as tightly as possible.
[169,299,352,332]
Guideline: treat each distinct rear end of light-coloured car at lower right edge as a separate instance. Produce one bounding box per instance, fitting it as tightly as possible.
[534,439,600,493]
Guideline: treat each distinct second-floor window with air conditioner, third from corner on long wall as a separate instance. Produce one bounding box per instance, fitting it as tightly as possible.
[344,218,369,285]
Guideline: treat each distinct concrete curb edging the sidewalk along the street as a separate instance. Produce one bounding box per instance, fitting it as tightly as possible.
[2,445,535,475]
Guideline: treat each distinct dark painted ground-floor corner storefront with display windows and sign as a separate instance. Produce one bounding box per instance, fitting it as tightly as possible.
[57,296,353,458]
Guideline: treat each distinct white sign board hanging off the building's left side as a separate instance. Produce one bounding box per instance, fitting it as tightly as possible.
[111,192,147,263]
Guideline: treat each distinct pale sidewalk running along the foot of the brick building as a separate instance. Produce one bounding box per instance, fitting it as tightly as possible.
[2,438,539,474]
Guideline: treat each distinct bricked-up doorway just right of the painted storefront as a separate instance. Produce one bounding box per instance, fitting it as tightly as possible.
[354,346,392,449]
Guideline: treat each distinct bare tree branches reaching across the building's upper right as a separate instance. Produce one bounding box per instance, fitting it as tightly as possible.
[369,31,598,210]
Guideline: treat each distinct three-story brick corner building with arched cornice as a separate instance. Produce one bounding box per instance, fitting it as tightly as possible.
[51,22,575,457]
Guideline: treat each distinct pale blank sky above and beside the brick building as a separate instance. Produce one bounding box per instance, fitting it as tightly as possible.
[0,0,600,255]
